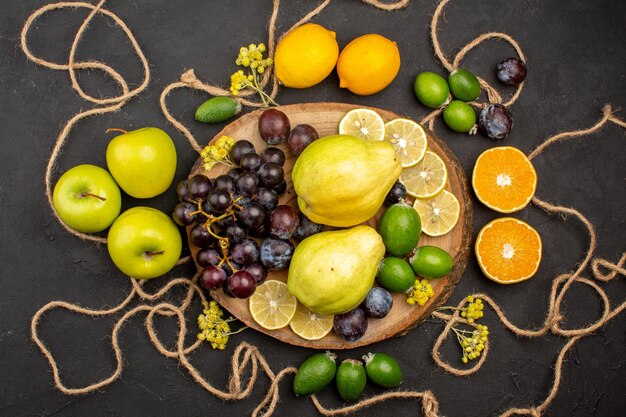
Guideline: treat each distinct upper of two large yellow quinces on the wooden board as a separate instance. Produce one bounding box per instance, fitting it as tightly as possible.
[291,135,402,227]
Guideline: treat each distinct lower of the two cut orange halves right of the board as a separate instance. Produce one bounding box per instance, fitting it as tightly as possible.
[475,217,542,284]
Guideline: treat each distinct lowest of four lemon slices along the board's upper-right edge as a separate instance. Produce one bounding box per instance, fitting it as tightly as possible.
[413,190,461,236]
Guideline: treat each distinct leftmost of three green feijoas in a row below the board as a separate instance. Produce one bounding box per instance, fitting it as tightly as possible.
[293,352,337,395]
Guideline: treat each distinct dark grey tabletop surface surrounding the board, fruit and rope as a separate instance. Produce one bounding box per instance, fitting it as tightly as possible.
[0,0,626,417]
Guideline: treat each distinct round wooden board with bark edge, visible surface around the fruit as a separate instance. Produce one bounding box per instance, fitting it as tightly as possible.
[187,103,472,349]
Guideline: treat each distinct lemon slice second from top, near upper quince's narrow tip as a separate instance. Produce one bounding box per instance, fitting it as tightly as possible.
[385,119,428,168]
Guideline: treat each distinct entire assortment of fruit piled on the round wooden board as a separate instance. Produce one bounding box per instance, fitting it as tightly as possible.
[180,105,460,342]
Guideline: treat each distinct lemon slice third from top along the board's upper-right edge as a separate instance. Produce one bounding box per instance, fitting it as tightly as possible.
[399,151,448,198]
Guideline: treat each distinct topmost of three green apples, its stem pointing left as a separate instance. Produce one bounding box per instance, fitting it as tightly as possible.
[107,127,176,198]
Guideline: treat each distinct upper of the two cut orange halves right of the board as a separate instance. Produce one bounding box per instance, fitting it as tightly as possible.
[472,146,537,213]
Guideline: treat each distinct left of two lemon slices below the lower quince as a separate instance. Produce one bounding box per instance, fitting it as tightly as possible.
[249,280,298,330]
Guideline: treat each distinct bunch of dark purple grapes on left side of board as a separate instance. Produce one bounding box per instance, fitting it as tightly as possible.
[173,140,323,298]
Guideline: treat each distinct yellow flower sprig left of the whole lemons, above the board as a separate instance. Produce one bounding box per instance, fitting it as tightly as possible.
[230,43,278,107]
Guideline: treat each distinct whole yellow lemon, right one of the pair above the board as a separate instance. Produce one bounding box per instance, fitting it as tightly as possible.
[337,33,400,96]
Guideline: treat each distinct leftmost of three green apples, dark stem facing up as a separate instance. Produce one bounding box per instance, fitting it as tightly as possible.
[52,164,122,233]
